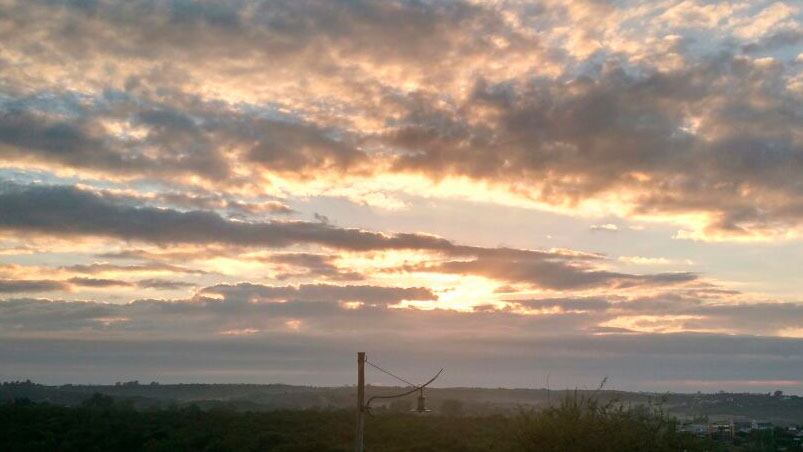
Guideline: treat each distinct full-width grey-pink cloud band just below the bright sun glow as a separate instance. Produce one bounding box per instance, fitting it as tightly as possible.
[0,288,803,341]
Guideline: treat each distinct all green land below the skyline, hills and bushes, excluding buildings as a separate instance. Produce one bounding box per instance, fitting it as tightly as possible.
[0,381,803,452]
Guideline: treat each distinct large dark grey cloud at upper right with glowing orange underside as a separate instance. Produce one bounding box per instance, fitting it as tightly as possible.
[390,56,803,237]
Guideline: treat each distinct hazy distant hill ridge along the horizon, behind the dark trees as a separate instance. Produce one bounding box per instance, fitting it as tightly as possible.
[0,381,803,425]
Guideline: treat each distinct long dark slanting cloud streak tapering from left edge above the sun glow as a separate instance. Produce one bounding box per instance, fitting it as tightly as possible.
[0,185,696,289]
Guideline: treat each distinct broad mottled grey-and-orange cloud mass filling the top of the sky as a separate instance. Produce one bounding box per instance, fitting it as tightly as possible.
[0,0,803,240]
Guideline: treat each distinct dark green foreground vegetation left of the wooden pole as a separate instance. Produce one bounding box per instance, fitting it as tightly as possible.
[0,394,353,452]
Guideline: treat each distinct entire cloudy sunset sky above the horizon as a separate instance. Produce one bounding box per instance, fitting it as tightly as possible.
[0,0,803,394]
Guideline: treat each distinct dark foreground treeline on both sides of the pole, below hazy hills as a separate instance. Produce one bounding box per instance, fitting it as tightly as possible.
[0,394,725,452]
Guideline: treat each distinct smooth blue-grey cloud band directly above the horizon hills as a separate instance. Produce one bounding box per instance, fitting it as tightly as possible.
[0,333,803,393]
